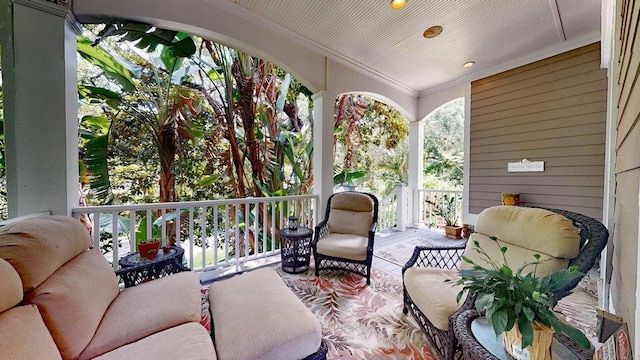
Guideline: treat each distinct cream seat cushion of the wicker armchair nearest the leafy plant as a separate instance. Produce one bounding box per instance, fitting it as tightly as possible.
[404,267,466,331]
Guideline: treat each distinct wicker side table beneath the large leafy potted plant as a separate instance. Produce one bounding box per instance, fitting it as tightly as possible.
[453,310,593,360]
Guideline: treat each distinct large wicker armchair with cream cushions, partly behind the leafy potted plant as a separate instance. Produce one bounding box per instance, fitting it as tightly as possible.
[402,206,609,359]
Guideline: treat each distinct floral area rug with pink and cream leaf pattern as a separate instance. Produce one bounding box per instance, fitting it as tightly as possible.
[276,268,435,360]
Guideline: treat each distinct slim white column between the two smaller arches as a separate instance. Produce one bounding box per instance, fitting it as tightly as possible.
[407,121,424,226]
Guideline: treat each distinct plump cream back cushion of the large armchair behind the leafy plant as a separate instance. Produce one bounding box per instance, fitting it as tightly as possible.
[462,206,580,276]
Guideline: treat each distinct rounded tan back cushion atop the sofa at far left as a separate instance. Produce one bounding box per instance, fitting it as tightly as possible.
[0,216,91,292]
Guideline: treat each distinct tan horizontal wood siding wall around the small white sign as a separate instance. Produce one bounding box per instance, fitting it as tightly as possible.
[468,43,607,219]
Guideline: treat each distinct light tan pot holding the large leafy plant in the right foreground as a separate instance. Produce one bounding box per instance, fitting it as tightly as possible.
[502,321,554,360]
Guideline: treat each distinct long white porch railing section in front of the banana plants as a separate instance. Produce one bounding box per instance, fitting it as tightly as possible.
[72,195,318,272]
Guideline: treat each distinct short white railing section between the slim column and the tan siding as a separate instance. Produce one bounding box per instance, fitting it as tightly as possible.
[413,189,462,226]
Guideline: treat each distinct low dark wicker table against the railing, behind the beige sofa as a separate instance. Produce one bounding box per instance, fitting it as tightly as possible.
[116,246,191,287]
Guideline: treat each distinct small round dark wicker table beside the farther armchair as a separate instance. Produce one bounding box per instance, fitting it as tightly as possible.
[280,227,313,274]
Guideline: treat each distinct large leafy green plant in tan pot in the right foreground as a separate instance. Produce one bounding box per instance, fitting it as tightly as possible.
[446,237,590,360]
